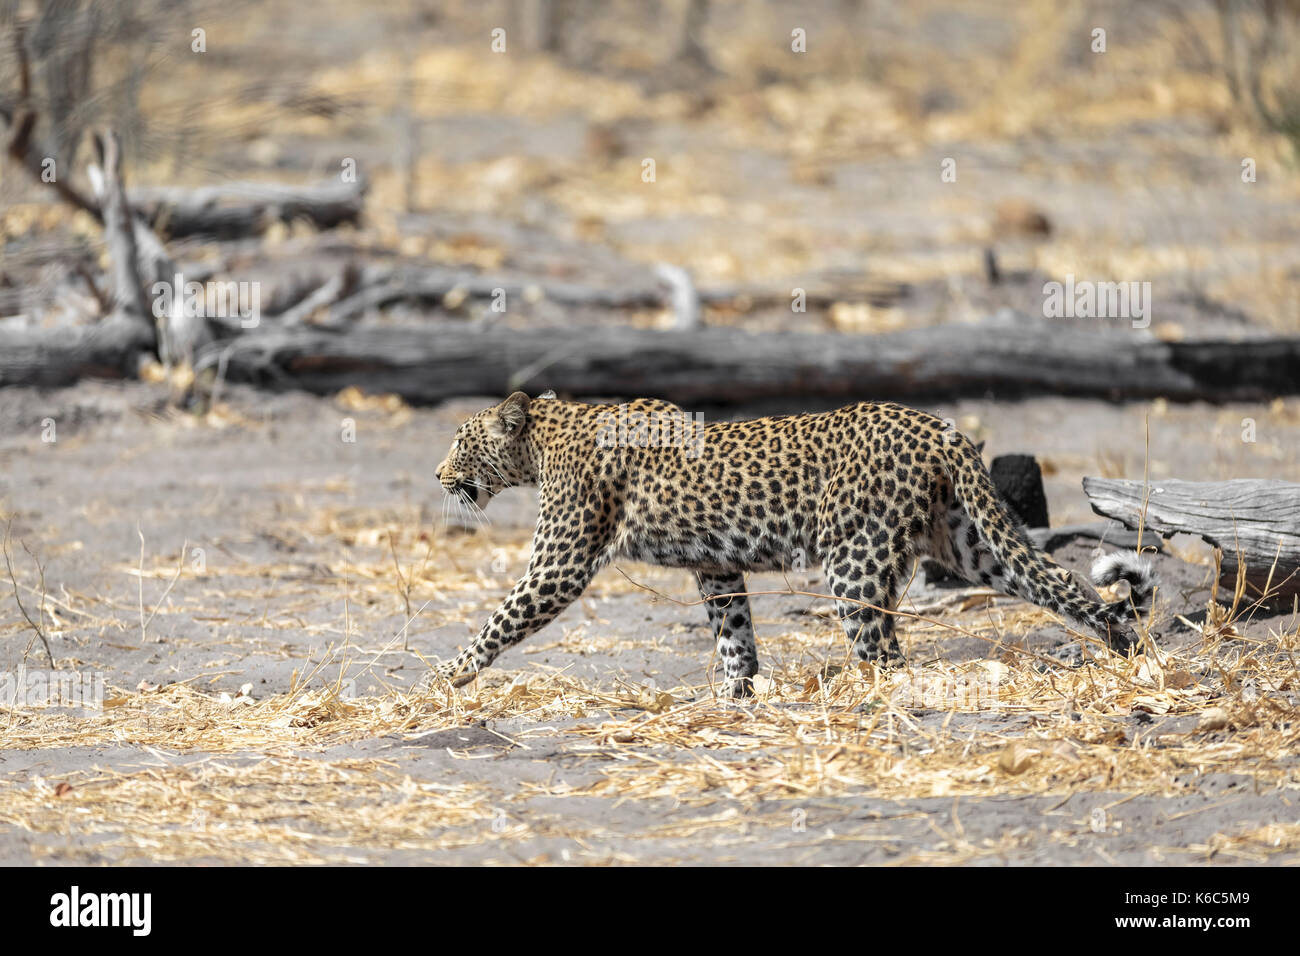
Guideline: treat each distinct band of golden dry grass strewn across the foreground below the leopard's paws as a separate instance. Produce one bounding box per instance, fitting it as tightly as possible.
[0,580,1300,862]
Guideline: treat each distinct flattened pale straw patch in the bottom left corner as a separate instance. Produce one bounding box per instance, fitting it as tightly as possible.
[0,757,501,864]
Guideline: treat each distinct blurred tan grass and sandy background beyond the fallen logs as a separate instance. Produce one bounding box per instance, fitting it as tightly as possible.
[0,0,1300,338]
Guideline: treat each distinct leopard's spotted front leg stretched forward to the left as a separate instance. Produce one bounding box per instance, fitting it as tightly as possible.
[420,497,606,689]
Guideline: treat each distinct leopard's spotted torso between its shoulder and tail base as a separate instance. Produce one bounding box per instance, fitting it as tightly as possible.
[590,402,944,571]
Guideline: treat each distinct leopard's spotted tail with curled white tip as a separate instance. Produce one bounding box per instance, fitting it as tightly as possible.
[946,436,1156,650]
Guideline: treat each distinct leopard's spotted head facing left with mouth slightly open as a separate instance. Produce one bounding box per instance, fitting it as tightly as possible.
[437,392,536,507]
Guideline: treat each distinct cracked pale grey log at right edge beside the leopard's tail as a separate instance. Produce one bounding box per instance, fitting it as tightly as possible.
[1083,477,1300,594]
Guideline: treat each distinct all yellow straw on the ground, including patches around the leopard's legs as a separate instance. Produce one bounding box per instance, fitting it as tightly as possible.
[0,509,1300,862]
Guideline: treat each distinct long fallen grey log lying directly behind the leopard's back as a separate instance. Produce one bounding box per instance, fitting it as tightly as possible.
[188,325,1300,405]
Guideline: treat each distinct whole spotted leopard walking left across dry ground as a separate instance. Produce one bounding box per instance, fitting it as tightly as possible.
[421,392,1156,698]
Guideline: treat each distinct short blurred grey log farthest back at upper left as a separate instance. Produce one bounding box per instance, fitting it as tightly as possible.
[130,181,365,239]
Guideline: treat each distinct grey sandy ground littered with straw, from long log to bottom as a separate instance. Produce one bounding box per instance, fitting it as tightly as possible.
[0,384,1300,865]
